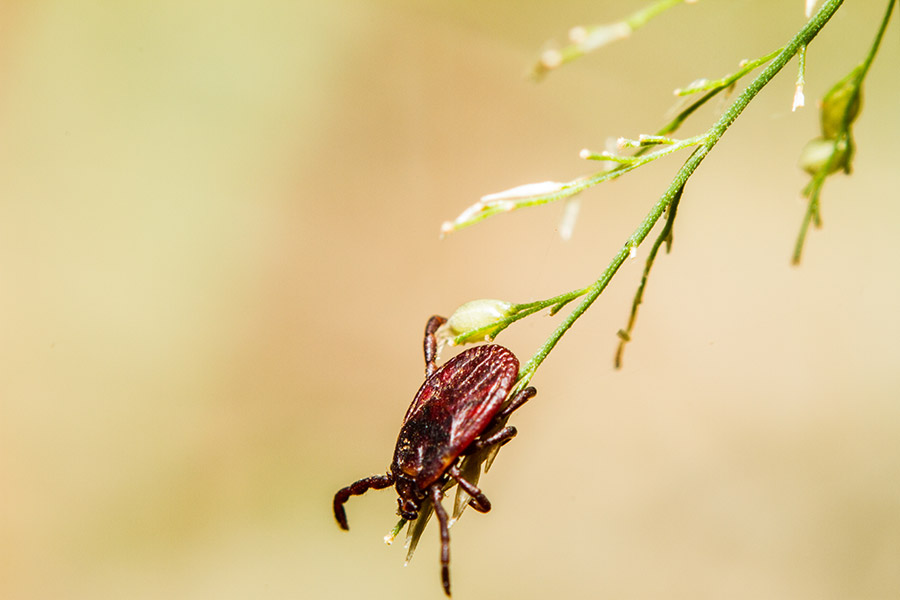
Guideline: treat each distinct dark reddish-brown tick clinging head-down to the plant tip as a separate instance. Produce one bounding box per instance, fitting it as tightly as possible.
[334,316,537,596]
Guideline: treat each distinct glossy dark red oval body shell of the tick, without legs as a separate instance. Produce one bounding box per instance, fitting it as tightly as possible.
[391,344,519,490]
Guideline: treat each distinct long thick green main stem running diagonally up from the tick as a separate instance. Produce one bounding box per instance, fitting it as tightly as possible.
[513,0,843,393]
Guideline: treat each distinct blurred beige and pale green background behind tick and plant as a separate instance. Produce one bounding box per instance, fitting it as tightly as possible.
[0,0,900,599]
